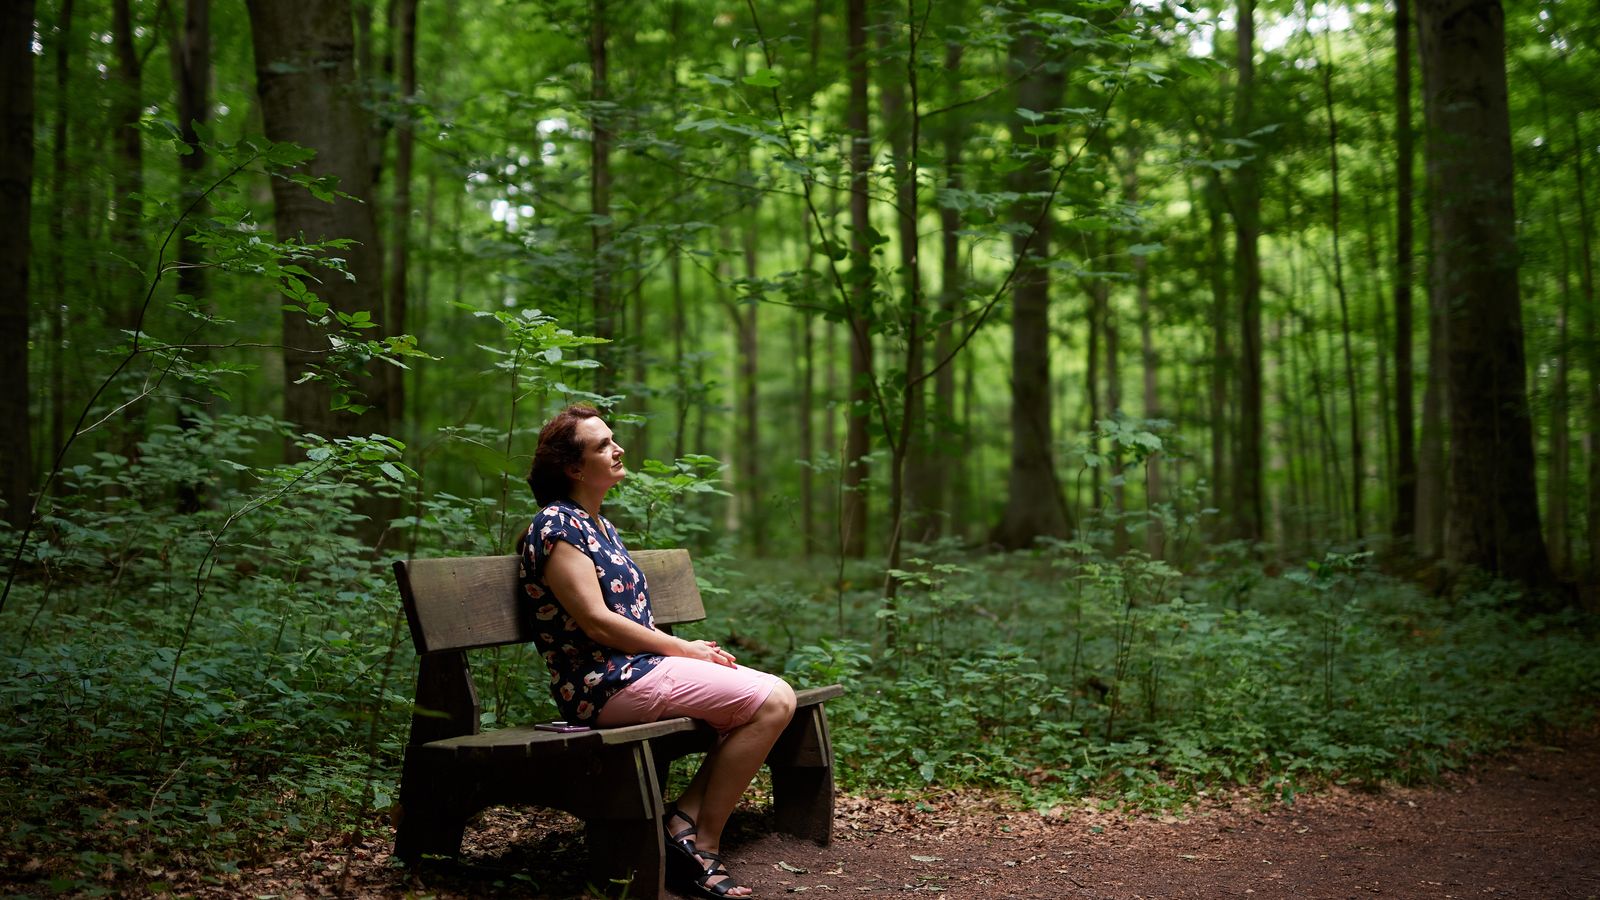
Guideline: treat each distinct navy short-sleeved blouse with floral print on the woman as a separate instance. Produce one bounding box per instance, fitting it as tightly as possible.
[517,500,662,722]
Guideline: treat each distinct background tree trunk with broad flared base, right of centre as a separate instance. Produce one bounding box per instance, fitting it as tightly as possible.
[992,35,1069,549]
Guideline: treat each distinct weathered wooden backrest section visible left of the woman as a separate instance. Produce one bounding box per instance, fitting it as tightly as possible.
[395,556,533,653]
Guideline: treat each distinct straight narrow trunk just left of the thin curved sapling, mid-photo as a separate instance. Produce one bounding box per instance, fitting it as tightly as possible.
[840,0,874,557]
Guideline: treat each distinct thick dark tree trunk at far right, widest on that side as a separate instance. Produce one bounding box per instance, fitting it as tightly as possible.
[1418,0,1552,589]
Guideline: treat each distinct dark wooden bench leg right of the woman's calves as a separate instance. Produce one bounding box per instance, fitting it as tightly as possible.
[766,703,834,847]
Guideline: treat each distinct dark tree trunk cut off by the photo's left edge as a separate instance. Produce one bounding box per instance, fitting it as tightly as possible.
[0,0,36,530]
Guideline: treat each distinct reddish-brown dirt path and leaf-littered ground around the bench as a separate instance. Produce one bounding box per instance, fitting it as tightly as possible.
[103,735,1600,898]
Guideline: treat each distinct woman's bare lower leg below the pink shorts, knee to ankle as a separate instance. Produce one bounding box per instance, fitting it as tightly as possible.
[678,681,795,897]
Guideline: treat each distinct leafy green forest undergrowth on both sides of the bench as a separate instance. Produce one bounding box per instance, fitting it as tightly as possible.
[0,416,1600,894]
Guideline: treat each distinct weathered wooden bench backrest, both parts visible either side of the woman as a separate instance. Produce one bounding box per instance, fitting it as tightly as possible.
[395,549,706,655]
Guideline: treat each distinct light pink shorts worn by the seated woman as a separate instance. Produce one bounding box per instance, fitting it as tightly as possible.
[595,657,778,735]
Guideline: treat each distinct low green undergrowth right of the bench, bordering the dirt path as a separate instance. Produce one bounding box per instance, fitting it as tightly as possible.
[716,543,1600,807]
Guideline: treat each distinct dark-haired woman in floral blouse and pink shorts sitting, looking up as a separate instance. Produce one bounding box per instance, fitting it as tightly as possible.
[518,405,795,898]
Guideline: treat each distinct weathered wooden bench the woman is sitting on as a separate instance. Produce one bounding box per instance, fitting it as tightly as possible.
[394,549,843,897]
